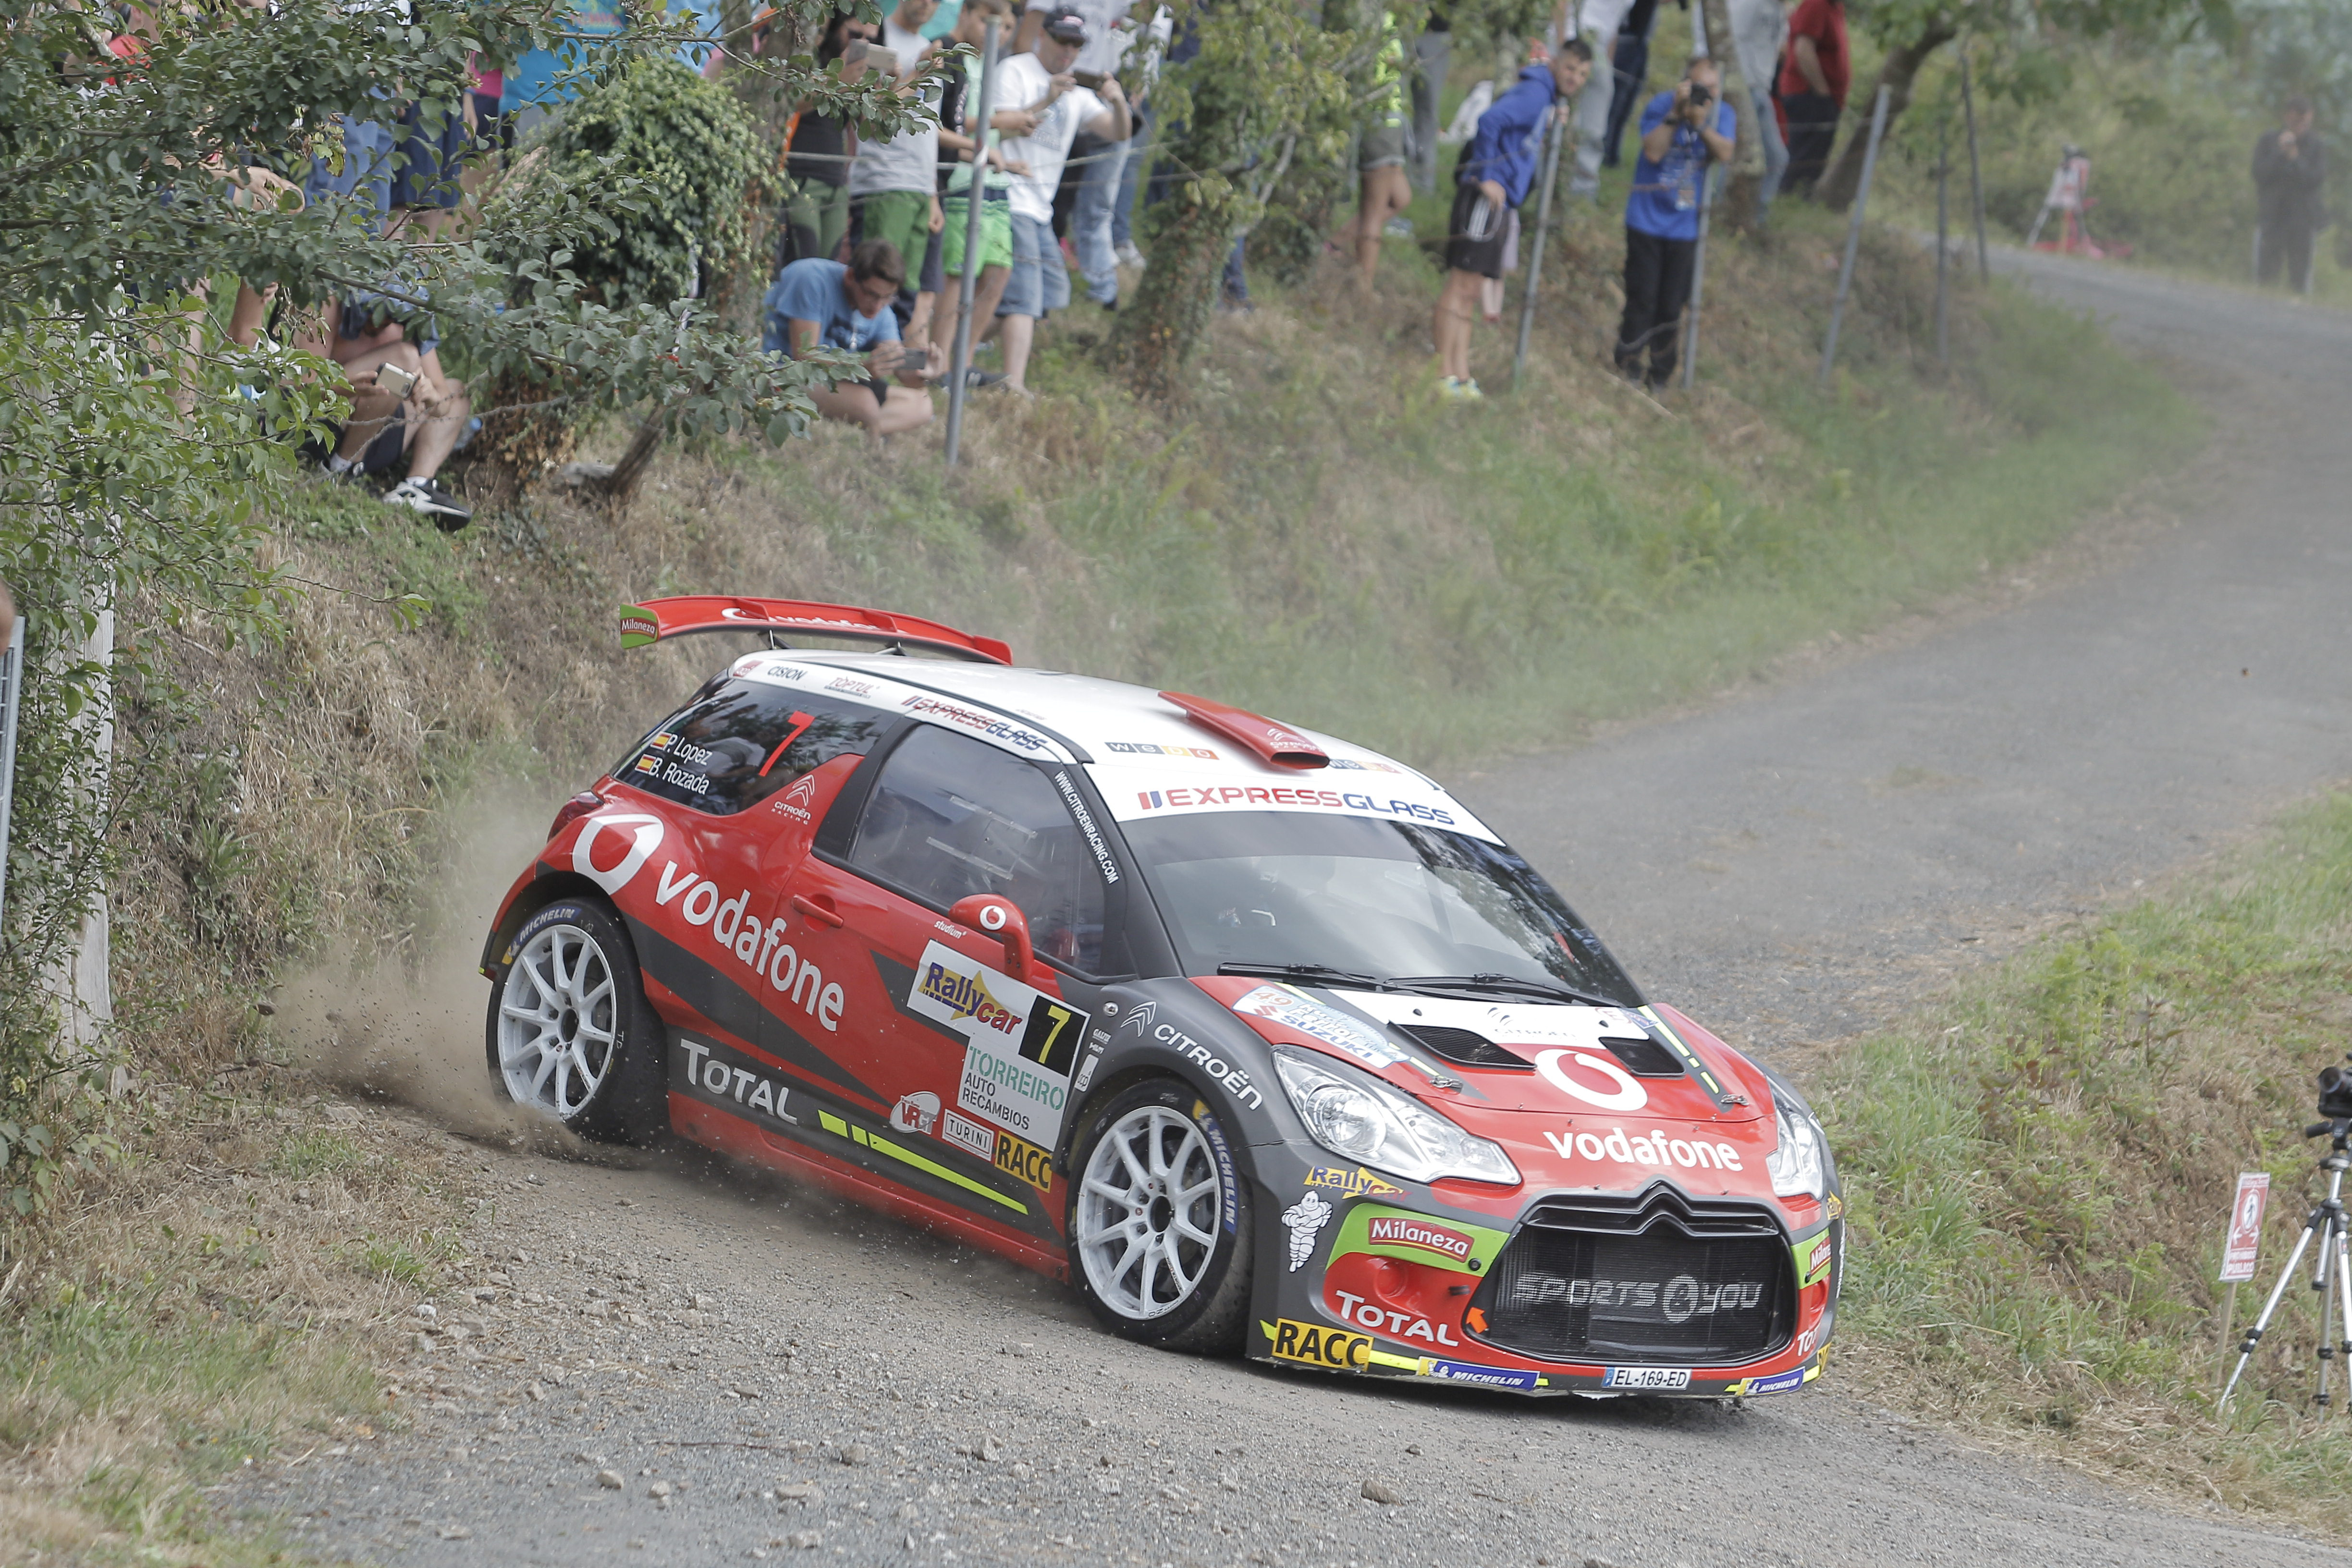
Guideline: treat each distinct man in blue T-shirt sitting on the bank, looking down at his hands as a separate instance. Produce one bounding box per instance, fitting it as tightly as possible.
[760,240,931,435]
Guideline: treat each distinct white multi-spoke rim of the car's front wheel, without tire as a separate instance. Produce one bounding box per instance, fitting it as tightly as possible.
[1075,1105,1225,1323]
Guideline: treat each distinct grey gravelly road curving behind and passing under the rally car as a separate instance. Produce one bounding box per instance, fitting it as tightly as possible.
[228,263,2352,1568]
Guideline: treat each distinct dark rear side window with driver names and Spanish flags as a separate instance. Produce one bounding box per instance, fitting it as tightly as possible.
[614,679,892,816]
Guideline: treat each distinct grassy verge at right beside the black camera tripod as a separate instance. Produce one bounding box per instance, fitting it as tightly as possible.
[1816,795,2352,1537]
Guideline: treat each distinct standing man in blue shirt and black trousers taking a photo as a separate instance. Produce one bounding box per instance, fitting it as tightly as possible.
[1616,54,1738,392]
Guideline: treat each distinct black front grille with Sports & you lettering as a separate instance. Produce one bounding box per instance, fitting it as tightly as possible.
[1470,1182,1797,1366]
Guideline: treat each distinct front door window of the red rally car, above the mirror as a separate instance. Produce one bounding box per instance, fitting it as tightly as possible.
[849,724,1103,973]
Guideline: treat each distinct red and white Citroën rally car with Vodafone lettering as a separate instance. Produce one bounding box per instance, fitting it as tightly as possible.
[482,597,1844,1396]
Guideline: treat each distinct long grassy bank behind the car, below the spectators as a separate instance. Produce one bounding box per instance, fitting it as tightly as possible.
[0,211,2199,1561]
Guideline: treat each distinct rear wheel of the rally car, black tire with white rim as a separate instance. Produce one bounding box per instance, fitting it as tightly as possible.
[482,898,670,1145]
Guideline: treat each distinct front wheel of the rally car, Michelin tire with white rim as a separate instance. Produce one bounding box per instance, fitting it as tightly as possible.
[1068,1079,1256,1352]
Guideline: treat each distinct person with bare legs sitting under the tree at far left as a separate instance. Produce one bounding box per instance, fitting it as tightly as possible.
[294,296,473,522]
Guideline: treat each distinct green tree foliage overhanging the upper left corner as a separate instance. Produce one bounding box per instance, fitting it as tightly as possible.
[0,0,910,1203]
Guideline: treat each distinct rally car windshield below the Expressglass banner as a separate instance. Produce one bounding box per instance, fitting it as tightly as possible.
[1122,811,1642,1006]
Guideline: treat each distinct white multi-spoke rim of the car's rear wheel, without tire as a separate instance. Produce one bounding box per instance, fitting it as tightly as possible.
[499,924,616,1121]
